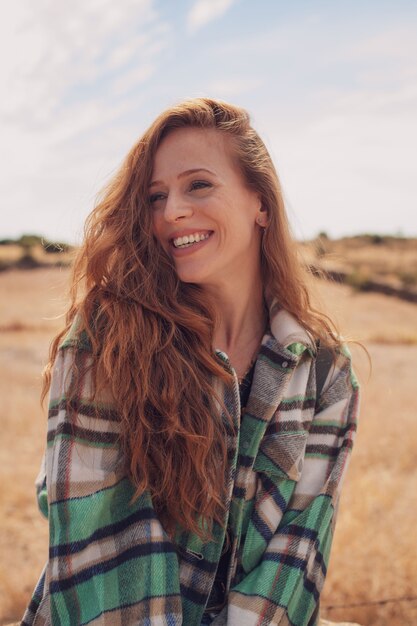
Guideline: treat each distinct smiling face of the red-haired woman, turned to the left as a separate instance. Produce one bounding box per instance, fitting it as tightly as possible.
[149,128,261,286]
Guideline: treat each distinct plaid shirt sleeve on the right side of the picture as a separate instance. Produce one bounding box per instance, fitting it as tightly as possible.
[219,347,359,626]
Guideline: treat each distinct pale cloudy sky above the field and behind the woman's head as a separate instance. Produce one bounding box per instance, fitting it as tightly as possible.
[0,0,417,244]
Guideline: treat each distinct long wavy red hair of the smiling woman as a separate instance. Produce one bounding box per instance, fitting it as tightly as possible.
[43,98,337,538]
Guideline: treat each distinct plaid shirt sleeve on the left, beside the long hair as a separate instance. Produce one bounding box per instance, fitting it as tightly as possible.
[22,346,182,626]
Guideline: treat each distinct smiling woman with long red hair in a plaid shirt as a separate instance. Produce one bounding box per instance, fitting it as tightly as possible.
[23,98,358,626]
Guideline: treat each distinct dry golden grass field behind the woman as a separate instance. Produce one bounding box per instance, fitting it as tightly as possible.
[0,268,417,626]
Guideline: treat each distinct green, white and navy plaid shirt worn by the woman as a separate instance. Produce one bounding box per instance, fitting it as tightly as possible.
[22,309,358,626]
